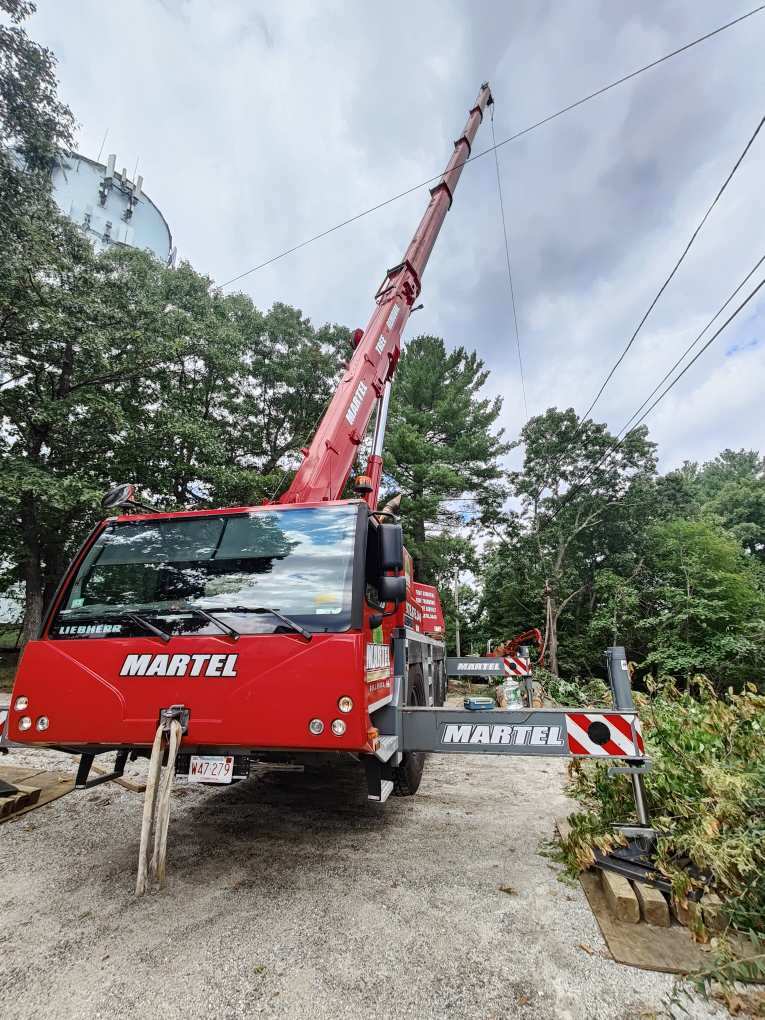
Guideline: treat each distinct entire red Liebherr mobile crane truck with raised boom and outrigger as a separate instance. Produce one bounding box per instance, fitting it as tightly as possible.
[0,85,648,829]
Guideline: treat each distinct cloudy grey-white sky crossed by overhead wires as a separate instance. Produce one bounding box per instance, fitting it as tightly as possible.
[30,0,765,469]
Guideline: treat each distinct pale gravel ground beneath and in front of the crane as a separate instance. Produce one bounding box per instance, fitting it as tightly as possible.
[0,752,724,1020]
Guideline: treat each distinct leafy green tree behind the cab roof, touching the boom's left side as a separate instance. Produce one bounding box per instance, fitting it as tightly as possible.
[114,271,350,507]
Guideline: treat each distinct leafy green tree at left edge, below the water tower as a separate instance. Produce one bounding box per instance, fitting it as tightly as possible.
[0,241,179,640]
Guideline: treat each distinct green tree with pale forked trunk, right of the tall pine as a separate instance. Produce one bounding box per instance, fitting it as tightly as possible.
[486,408,656,675]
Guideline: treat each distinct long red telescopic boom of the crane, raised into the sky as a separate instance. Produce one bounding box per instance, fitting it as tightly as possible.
[278,84,493,508]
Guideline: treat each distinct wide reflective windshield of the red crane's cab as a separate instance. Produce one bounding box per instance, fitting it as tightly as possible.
[50,505,358,638]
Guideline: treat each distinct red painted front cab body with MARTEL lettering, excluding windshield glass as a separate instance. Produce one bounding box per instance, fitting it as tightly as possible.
[8,500,432,752]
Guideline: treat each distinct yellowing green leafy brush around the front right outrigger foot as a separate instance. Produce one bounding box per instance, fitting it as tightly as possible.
[563,677,765,934]
